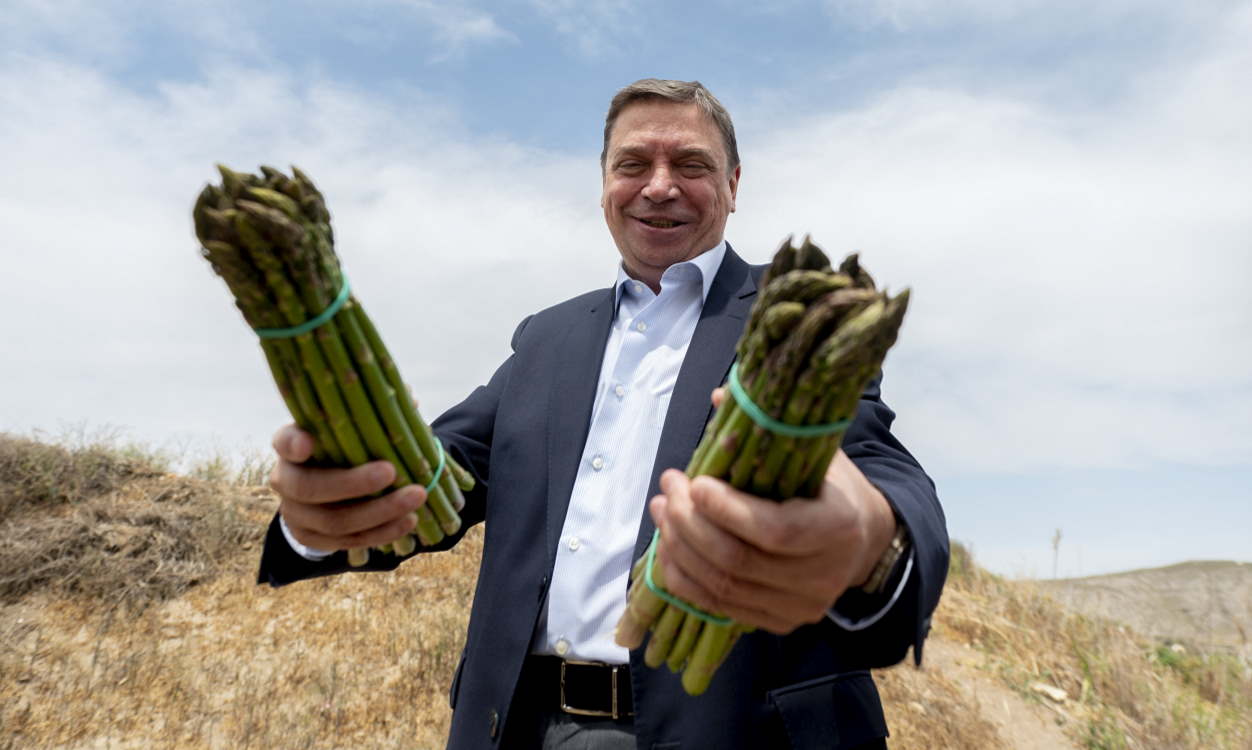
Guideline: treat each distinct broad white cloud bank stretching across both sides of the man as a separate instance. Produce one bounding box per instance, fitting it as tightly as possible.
[0,5,1252,488]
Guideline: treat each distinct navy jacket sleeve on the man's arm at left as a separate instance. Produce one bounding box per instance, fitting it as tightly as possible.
[257,318,530,586]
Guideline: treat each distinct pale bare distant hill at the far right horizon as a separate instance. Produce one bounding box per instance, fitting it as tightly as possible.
[1039,561,1252,660]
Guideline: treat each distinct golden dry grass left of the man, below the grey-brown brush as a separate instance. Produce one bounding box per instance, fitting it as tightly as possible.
[0,535,481,749]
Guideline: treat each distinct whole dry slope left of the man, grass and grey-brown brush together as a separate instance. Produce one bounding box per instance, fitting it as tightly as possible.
[0,436,482,749]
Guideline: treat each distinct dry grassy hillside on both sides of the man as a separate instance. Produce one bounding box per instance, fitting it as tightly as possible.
[0,434,1252,750]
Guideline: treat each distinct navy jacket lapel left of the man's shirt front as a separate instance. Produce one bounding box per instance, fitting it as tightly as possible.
[545,288,616,570]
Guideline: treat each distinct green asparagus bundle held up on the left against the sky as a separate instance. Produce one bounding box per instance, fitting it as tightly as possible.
[193,165,473,566]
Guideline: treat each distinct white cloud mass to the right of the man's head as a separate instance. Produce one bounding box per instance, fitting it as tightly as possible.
[735,4,1252,473]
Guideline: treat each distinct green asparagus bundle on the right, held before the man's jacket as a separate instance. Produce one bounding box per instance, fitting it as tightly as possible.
[616,238,909,695]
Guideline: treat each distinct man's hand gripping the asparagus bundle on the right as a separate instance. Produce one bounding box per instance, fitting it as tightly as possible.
[650,393,895,635]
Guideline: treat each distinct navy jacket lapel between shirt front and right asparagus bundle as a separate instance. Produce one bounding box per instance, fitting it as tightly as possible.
[631,244,756,558]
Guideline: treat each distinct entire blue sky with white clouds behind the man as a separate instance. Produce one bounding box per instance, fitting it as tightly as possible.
[0,0,1252,576]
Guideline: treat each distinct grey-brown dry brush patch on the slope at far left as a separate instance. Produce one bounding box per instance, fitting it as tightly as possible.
[0,436,263,606]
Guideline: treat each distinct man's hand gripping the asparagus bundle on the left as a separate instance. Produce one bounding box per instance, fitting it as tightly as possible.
[269,424,426,551]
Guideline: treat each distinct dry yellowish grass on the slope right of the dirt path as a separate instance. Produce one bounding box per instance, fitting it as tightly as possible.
[935,545,1252,750]
